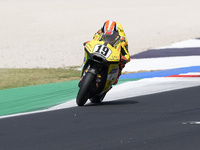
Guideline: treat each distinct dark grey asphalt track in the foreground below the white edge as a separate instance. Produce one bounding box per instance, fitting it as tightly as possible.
[0,86,200,150]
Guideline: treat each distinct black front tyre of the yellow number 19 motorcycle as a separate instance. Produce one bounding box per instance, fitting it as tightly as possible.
[76,72,95,106]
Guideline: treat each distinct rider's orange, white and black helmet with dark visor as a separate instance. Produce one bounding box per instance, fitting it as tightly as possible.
[101,20,119,45]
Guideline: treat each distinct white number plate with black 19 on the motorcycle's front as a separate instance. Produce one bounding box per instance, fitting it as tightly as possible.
[93,45,112,58]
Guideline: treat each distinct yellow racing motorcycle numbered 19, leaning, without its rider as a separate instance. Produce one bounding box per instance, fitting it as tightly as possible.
[76,34,121,106]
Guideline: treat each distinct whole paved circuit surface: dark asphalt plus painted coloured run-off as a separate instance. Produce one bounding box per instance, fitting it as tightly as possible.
[0,39,200,150]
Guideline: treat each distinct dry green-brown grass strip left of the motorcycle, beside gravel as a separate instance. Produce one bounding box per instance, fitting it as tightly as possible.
[0,67,80,90]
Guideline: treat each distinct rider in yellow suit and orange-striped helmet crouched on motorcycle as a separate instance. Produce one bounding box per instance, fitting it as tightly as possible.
[84,20,130,85]
